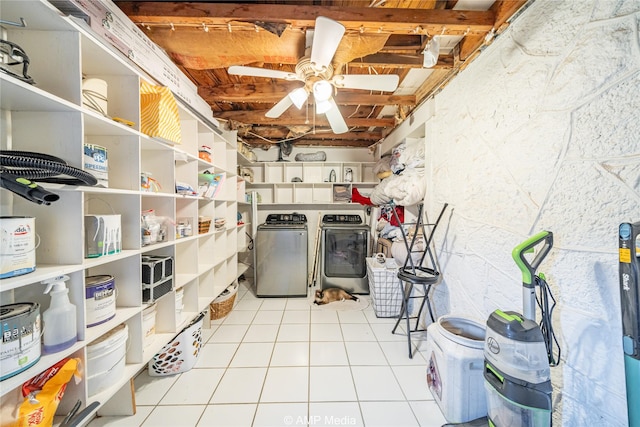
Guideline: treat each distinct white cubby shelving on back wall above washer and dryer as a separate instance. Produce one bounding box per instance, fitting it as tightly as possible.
[242,162,379,207]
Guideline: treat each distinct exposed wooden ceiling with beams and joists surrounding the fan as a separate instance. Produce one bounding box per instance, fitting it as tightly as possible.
[115,0,533,148]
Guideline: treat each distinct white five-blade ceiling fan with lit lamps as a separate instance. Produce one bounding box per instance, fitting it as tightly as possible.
[228,16,399,134]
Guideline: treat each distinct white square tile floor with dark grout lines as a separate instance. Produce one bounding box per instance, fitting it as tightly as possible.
[89,282,446,427]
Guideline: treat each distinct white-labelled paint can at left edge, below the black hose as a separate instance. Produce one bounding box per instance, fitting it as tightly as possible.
[0,216,36,279]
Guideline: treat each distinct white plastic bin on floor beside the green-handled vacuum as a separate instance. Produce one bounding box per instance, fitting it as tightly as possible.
[426,316,487,423]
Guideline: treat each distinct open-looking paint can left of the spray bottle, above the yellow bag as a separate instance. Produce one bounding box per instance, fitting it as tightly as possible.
[0,302,41,381]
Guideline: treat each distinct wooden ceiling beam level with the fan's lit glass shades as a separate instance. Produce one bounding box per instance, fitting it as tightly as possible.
[198,83,417,105]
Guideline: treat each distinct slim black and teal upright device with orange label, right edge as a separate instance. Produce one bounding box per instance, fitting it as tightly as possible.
[618,222,640,427]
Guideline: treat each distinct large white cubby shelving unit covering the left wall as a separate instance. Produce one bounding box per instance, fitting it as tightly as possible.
[0,1,239,422]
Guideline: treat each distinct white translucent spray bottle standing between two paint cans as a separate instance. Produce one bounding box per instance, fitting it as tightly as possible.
[42,276,78,353]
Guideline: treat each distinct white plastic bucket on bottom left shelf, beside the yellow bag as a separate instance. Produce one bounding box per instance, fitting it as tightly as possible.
[87,324,129,396]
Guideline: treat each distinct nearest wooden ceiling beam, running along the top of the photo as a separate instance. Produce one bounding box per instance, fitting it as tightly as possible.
[116,0,496,35]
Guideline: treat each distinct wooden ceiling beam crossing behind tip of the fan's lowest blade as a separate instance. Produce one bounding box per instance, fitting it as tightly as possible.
[214,109,396,128]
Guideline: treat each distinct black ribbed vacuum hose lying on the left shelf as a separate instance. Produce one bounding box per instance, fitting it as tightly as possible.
[0,150,98,205]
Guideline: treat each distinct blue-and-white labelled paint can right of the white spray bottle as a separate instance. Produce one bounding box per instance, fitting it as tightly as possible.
[84,274,116,327]
